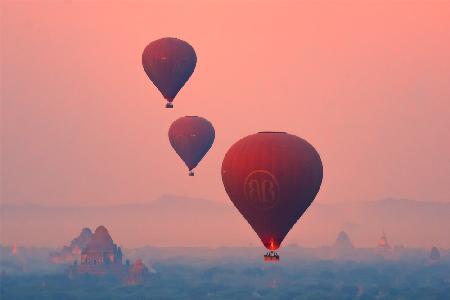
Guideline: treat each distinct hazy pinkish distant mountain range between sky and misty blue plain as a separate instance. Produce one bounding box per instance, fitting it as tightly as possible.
[1,196,450,248]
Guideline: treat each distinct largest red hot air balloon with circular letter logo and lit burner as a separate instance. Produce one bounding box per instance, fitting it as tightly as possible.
[222,132,323,260]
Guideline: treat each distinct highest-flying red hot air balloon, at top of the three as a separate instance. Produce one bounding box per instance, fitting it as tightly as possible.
[142,38,197,108]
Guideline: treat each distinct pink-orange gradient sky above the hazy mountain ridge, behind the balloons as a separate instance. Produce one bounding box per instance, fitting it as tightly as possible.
[0,0,450,209]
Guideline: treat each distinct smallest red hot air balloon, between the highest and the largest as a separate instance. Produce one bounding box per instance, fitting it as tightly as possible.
[169,116,215,176]
